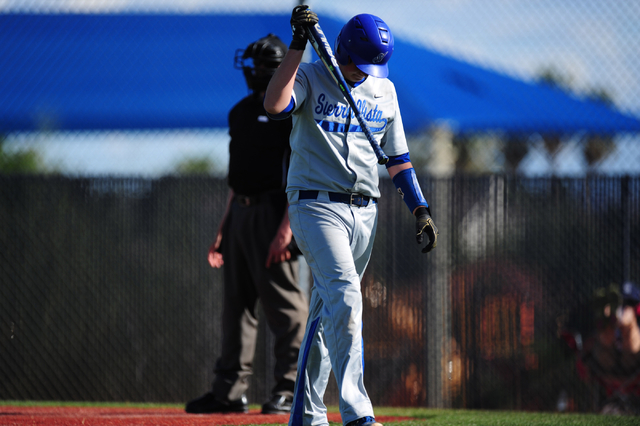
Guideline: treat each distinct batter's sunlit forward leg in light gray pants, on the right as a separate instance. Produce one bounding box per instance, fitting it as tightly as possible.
[289,201,376,424]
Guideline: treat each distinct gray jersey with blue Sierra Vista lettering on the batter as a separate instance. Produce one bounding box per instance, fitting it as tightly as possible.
[287,61,409,202]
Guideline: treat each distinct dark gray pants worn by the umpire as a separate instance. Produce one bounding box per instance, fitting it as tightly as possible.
[212,194,308,401]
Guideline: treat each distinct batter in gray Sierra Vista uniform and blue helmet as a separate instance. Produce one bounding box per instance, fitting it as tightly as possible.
[264,5,438,426]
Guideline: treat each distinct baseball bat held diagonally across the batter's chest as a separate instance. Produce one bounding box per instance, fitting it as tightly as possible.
[307,24,389,164]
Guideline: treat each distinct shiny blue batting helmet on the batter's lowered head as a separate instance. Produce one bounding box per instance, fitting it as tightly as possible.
[333,13,393,78]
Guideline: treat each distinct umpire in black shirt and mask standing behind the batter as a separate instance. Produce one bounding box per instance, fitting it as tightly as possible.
[186,34,308,414]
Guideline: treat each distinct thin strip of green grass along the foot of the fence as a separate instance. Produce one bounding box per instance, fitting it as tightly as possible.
[0,401,640,426]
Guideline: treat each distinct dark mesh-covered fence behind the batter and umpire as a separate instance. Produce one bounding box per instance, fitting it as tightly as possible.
[0,175,640,411]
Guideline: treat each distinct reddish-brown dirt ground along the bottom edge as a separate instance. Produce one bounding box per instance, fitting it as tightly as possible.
[0,406,407,426]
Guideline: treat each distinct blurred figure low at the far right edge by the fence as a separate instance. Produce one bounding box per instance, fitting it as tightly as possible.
[578,282,640,415]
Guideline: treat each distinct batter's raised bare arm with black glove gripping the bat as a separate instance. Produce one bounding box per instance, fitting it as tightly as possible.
[264,6,318,115]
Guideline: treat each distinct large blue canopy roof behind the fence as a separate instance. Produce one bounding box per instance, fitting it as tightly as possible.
[0,14,640,134]
